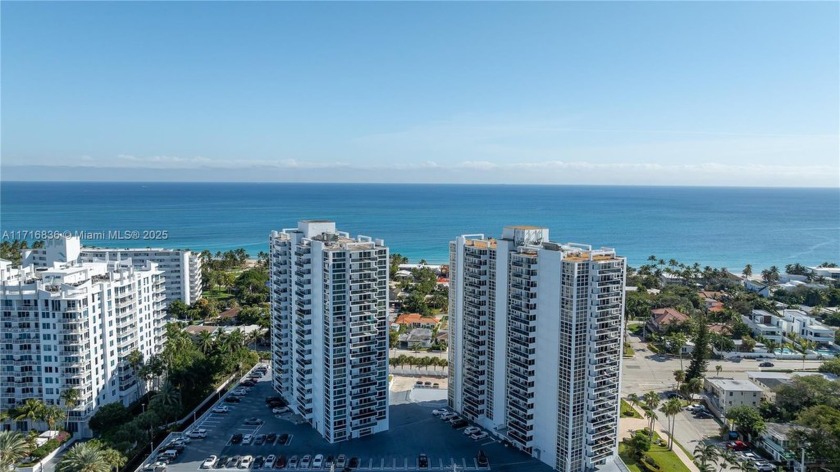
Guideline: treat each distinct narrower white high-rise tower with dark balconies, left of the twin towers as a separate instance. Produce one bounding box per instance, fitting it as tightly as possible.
[269,220,388,442]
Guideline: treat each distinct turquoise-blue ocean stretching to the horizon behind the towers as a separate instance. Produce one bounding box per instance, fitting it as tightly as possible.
[0,182,840,270]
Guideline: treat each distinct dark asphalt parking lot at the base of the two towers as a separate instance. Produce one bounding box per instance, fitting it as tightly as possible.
[148,366,551,472]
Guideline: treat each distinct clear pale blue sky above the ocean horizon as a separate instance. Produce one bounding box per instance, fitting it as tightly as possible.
[0,2,840,187]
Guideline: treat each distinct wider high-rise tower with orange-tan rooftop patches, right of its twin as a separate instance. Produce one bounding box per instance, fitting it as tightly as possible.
[448,226,625,472]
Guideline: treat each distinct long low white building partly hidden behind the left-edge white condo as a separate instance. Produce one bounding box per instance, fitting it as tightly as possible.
[21,237,202,305]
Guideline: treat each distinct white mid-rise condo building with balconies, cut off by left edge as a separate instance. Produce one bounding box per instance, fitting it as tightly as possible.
[0,254,166,437]
